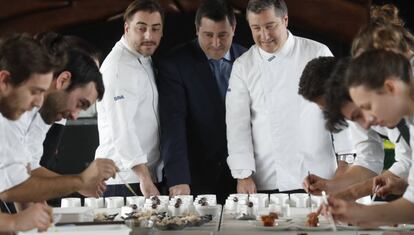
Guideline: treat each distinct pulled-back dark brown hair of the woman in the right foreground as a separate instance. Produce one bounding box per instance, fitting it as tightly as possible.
[346,49,412,90]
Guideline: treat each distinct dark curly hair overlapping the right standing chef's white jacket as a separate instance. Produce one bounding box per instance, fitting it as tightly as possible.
[298,56,338,102]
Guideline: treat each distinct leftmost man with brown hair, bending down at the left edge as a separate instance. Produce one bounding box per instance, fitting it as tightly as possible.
[0,35,55,233]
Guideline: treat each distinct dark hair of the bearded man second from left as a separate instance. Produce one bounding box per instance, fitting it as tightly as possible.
[64,50,105,100]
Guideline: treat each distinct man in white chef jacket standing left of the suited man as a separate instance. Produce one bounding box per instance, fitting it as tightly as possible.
[95,0,163,197]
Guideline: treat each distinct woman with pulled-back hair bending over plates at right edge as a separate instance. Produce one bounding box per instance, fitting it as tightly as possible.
[329,50,414,226]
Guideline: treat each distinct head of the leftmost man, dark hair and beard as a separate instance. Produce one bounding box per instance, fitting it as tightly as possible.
[0,35,54,120]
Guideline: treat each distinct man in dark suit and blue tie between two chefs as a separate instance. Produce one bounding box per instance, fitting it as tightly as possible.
[158,0,246,203]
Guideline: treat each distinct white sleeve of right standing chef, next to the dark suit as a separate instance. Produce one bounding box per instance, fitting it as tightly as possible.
[226,60,256,173]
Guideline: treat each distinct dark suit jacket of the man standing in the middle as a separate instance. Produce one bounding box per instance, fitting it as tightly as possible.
[158,39,246,193]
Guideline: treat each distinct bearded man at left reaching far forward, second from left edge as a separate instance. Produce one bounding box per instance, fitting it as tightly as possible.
[0,45,117,202]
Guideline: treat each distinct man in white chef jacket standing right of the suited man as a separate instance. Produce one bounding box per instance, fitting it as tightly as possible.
[226,0,350,193]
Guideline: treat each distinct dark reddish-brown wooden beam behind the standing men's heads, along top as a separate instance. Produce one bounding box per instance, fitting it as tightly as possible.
[0,0,371,41]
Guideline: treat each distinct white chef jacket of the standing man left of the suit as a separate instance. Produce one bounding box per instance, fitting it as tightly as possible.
[95,37,162,184]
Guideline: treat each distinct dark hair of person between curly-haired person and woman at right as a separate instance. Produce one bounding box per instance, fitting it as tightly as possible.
[323,57,352,132]
